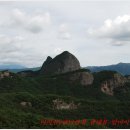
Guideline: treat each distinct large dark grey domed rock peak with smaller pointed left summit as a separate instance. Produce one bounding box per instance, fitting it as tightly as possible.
[40,51,80,74]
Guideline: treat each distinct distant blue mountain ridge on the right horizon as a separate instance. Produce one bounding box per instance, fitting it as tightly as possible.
[86,63,130,75]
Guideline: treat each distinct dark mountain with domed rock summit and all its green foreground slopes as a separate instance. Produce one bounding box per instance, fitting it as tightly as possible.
[0,51,130,129]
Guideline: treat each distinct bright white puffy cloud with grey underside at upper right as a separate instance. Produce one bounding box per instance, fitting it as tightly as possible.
[87,15,130,46]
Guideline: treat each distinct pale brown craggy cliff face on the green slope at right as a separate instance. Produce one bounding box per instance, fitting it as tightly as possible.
[101,74,128,95]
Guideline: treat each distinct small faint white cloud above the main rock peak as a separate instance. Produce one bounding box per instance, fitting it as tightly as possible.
[58,24,71,40]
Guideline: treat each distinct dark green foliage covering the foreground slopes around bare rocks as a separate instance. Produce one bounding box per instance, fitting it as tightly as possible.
[0,70,130,128]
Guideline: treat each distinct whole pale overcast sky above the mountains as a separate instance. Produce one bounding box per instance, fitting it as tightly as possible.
[0,0,130,67]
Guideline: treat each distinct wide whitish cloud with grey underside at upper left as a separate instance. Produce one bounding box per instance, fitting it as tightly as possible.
[3,9,51,33]
